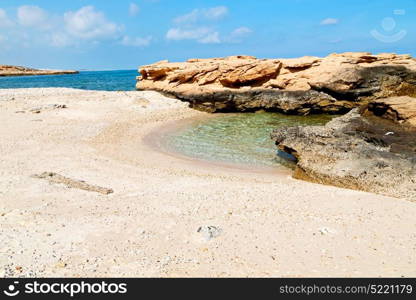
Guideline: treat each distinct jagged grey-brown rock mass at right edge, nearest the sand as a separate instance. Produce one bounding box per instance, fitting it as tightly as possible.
[272,97,416,201]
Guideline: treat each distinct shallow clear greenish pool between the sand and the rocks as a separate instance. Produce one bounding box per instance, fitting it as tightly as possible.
[165,112,334,167]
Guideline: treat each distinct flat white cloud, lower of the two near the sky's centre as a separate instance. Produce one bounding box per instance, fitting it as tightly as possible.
[166,27,220,44]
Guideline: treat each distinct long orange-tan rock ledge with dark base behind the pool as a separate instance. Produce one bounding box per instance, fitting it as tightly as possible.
[137,52,416,114]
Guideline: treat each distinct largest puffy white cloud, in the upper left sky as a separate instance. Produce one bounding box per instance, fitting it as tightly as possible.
[64,6,122,40]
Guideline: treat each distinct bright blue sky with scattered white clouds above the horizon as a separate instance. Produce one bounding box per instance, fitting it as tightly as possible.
[0,0,416,70]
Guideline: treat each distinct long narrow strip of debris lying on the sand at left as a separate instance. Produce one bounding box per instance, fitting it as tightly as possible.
[31,172,114,195]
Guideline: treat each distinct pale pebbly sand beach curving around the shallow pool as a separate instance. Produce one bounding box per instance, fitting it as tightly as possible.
[0,88,416,277]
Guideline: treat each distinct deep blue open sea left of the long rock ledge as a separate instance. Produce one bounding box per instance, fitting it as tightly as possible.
[0,70,139,91]
